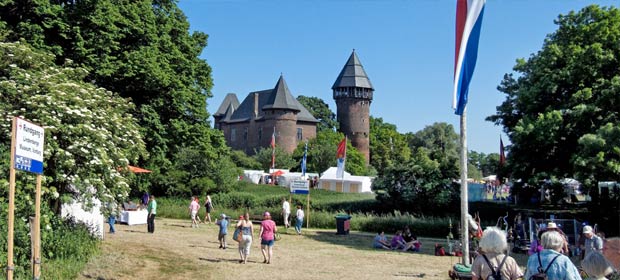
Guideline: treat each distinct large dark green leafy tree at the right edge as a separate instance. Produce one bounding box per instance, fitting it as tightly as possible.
[487,5,620,188]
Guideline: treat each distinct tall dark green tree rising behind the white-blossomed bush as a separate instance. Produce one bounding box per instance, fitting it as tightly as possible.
[0,0,227,192]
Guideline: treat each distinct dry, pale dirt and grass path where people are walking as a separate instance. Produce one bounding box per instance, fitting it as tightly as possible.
[77,219,470,280]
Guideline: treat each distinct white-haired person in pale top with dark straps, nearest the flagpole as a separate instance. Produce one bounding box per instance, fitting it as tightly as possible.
[471,227,523,280]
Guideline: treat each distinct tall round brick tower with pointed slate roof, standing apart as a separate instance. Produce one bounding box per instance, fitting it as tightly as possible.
[332,50,375,164]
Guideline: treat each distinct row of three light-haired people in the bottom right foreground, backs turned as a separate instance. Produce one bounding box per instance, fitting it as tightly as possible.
[472,223,620,280]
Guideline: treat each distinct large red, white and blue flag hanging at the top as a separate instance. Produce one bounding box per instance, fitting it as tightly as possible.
[452,0,485,115]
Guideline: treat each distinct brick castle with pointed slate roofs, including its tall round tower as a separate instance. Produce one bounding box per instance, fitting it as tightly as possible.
[213,50,374,164]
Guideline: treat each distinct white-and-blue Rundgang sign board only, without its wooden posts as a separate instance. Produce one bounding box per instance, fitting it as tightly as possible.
[13,118,45,174]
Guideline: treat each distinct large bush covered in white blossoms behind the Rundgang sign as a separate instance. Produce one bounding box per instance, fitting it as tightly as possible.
[0,42,146,210]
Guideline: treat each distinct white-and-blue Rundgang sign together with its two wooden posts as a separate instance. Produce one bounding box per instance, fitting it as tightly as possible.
[6,117,45,280]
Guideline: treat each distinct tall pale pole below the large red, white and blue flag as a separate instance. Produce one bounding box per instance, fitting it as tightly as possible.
[460,107,469,265]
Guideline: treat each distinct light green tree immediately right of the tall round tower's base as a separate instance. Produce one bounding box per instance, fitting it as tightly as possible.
[370,117,411,174]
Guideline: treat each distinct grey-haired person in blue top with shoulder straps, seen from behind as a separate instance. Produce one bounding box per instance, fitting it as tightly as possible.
[525,231,581,280]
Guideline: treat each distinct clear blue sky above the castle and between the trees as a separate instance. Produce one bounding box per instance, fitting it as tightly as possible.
[179,0,618,153]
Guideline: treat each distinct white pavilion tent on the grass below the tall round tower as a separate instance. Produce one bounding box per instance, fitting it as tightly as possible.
[318,167,372,193]
